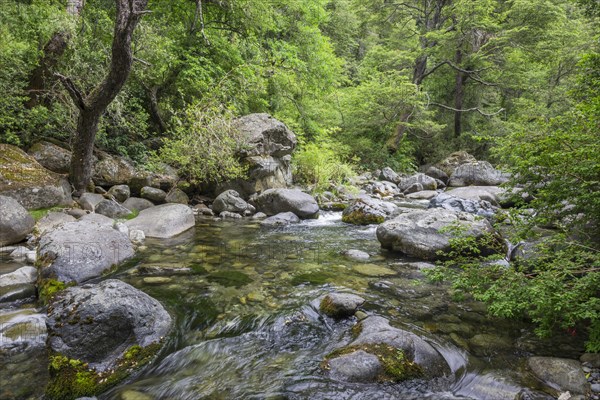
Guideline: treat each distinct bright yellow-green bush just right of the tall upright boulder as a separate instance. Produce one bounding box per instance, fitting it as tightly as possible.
[293,129,355,191]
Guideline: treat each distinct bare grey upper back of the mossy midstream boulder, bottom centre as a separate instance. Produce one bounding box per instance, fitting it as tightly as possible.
[350,315,450,377]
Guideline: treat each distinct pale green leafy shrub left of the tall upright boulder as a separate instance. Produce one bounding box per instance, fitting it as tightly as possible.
[156,104,247,182]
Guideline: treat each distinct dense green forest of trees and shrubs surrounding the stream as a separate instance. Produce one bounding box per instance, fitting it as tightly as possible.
[0,0,600,368]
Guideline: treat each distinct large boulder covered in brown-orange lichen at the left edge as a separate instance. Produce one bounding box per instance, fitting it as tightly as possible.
[0,143,72,210]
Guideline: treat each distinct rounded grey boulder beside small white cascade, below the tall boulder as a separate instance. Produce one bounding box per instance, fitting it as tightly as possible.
[256,189,319,219]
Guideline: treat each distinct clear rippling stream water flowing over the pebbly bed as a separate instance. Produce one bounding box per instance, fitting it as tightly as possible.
[0,213,582,400]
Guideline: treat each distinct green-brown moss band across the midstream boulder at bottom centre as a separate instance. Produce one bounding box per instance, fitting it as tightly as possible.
[321,342,423,382]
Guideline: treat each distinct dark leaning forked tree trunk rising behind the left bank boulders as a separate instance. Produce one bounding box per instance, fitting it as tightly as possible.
[56,0,148,194]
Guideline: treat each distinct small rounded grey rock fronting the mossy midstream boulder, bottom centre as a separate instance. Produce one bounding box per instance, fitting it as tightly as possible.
[328,350,383,383]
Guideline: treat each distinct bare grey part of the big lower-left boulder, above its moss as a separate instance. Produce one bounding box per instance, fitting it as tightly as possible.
[47,279,171,372]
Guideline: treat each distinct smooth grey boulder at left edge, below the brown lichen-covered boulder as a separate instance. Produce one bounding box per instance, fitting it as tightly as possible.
[0,196,35,246]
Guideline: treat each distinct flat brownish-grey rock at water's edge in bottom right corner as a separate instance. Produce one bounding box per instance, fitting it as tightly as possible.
[527,357,591,396]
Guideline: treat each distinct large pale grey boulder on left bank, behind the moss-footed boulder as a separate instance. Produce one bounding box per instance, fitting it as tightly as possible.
[38,219,134,284]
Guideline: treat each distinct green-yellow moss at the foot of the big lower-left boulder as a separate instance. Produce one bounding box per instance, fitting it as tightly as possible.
[45,343,162,400]
